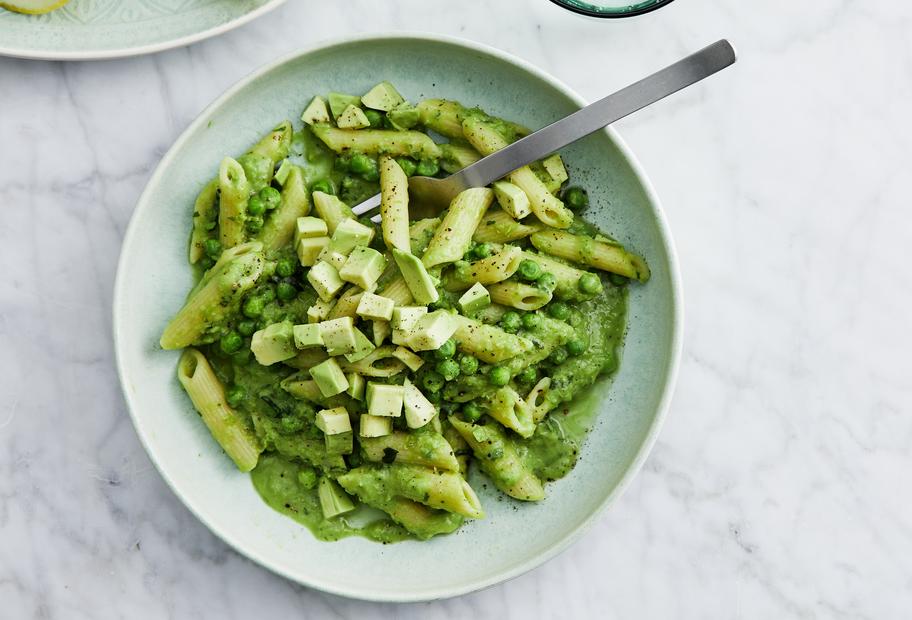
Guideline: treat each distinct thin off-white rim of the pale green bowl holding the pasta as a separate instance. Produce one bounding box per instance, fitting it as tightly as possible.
[112,31,683,603]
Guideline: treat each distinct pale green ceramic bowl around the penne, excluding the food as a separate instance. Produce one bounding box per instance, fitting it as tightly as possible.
[114,35,681,601]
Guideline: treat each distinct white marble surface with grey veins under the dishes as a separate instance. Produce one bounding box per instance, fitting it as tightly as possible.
[0,0,912,619]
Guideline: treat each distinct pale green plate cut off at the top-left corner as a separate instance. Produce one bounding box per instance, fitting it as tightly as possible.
[0,0,285,60]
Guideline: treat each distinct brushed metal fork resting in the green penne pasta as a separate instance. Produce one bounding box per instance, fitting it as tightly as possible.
[352,39,736,220]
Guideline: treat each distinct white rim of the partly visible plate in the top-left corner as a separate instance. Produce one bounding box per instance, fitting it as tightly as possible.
[0,0,288,61]
